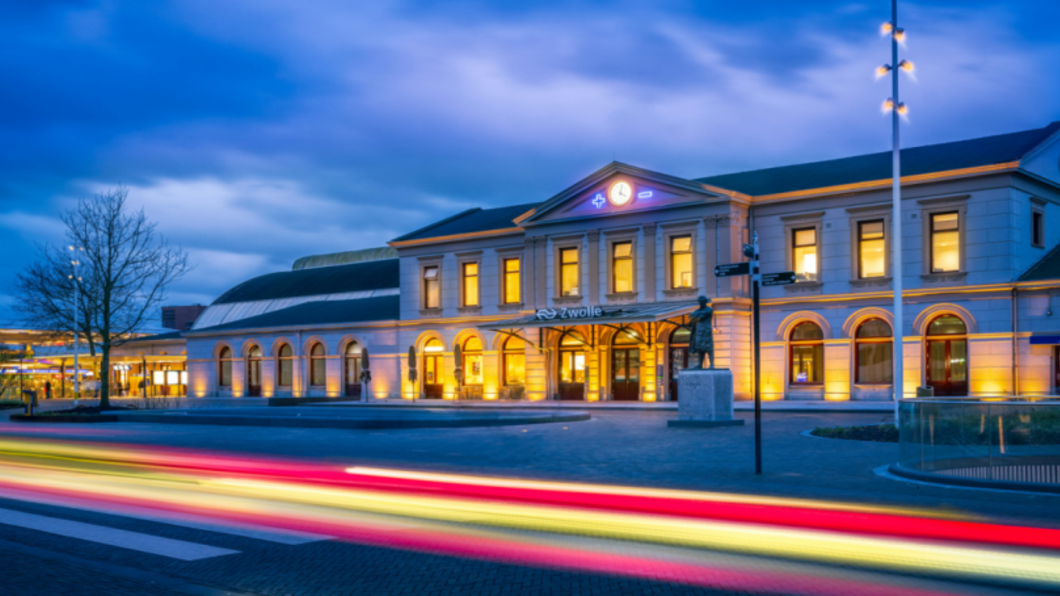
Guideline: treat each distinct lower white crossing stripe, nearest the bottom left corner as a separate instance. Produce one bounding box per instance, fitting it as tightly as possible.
[0,502,240,561]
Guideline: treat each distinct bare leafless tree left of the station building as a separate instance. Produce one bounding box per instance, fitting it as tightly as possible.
[15,188,190,408]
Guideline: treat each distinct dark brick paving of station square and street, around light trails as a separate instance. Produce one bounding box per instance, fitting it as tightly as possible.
[0,411,1060,596]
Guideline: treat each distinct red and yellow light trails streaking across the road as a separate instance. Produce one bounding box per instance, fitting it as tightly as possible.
[0,439,1060,594]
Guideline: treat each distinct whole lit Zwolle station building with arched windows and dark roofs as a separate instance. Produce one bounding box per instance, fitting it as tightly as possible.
[183,123,1060,402]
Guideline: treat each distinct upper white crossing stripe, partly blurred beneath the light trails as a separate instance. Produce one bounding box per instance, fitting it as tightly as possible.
[0,488,334,546]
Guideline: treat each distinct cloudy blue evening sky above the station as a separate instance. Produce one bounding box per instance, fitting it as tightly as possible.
[0,0,1060,319]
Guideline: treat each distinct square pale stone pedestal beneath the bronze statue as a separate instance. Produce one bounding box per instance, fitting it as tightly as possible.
[667,368,743,428]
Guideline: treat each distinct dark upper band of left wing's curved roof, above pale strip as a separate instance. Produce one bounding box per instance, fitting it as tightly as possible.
[213,259,400,304]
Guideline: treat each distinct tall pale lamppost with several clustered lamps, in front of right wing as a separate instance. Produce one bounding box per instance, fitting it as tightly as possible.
[876,0,913,417]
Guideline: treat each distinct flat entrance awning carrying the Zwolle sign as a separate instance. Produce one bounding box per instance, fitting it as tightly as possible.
[478,301,700,330]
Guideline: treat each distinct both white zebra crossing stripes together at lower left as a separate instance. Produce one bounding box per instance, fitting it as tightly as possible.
[0,488,332,561]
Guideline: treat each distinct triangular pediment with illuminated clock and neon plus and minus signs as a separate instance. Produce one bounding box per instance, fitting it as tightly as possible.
[516,162,741,226]
